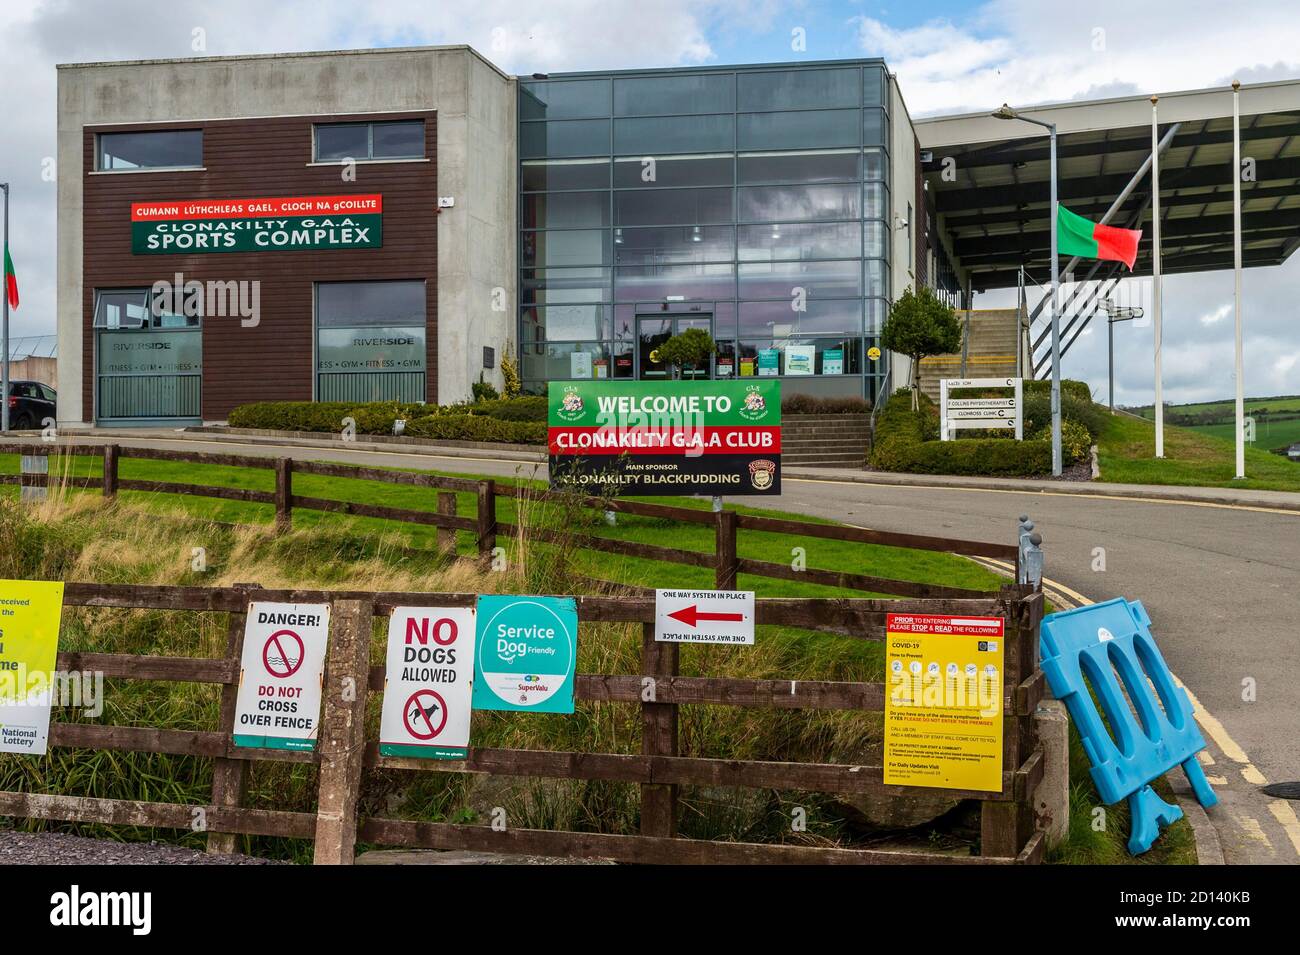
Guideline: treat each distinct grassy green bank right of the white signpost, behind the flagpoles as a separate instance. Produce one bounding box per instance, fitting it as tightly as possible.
[1097,414,1300,491]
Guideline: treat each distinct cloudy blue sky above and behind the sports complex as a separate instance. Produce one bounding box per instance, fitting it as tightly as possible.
[0,0,1300,404]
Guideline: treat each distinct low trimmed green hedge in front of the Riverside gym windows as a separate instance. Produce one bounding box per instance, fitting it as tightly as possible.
[228,398,546,444]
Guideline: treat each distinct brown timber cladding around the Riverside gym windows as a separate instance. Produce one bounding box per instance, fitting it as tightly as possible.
[81,110,438,421]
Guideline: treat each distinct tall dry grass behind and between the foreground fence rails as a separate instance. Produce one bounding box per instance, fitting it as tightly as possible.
[0,488,925,859]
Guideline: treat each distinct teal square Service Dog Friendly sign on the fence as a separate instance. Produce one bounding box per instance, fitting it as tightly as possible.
[473,595,577,713]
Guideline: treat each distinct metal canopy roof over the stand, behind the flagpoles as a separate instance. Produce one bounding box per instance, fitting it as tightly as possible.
[915,82,1300,291]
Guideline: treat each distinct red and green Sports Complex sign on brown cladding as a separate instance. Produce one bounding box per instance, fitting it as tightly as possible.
[131,194,384,255]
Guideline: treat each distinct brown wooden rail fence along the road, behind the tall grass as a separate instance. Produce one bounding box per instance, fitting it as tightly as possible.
[0,443,1021,599]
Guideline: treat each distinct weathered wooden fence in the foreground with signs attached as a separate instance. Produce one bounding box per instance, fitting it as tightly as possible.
[0,583,1044,864]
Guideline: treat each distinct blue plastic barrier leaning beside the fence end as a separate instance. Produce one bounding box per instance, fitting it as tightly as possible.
[1040,598,1218,855]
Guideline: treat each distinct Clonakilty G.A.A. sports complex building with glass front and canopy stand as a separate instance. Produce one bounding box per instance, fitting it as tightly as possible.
[57,47,1300,426]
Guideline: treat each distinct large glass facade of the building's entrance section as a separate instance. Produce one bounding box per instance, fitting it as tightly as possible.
[519,61,891,398]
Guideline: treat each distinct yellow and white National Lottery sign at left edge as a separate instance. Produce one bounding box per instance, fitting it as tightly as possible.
[0,581,64,756]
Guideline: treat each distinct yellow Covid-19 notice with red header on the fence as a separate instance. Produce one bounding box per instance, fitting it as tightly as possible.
[884,613,1005,793]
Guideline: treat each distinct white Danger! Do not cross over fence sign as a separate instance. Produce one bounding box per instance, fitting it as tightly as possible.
[234,603,329,750]
